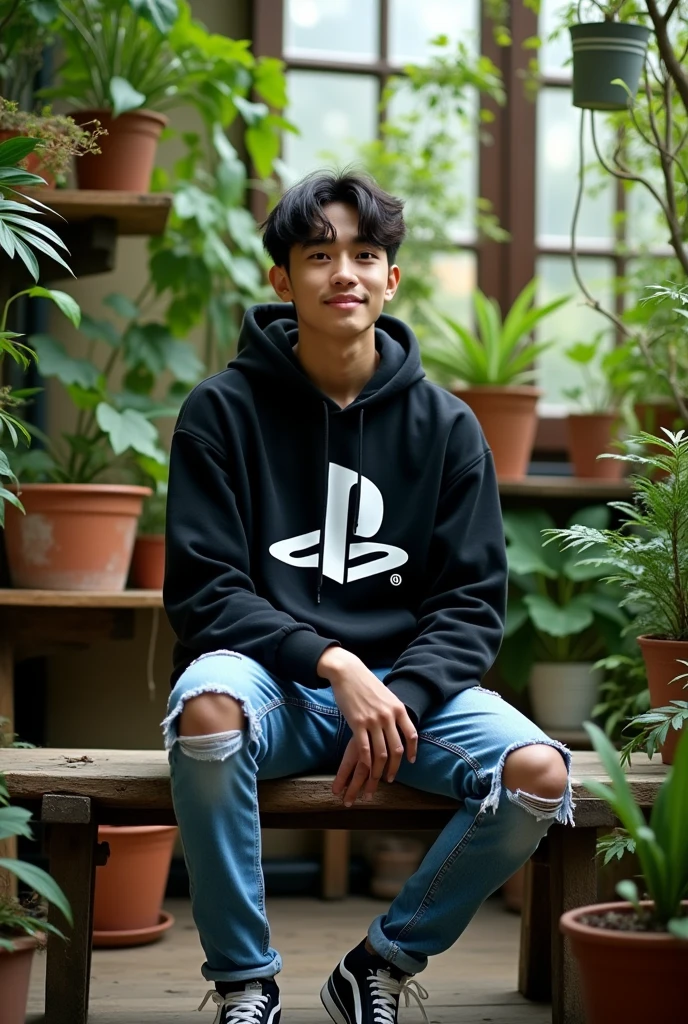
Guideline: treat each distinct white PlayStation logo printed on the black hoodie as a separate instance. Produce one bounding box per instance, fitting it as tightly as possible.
[269,462,409,583]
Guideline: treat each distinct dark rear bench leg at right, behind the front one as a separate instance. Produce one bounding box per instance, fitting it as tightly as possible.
[518,836,552,1002]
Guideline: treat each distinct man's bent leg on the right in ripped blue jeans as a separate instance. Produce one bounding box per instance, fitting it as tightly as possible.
[368,687,572,974]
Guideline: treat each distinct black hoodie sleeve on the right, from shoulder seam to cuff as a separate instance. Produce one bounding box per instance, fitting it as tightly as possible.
[385,423,508,722]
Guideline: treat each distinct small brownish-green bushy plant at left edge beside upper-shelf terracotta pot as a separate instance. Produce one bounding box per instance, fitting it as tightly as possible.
[0,96,104,188]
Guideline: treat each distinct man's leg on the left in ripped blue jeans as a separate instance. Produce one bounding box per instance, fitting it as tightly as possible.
[162,651,342,987]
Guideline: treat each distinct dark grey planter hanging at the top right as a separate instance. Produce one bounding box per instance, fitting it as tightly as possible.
[569,22,650,111]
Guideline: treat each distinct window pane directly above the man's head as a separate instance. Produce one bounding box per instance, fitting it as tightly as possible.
[284,71,379,177]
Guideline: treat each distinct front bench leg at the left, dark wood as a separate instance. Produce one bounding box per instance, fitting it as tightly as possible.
[45,821,98,1024]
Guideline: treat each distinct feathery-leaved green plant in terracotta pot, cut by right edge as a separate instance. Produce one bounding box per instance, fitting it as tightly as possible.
[546,430,688,764]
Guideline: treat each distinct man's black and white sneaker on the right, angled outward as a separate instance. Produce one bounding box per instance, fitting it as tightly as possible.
[320,939,428,1024]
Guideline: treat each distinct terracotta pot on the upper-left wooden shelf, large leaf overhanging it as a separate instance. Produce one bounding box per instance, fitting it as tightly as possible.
[70,111,167,193]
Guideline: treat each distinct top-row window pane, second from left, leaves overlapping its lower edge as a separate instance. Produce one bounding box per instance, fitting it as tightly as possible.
[389,0,480,63]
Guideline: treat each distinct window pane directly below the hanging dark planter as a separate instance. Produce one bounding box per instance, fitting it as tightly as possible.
[535,87,615,246]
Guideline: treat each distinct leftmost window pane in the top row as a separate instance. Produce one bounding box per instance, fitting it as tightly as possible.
[285,0,380,61]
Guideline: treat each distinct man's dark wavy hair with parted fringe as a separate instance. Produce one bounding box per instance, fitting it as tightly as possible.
[261,170,406,269]
